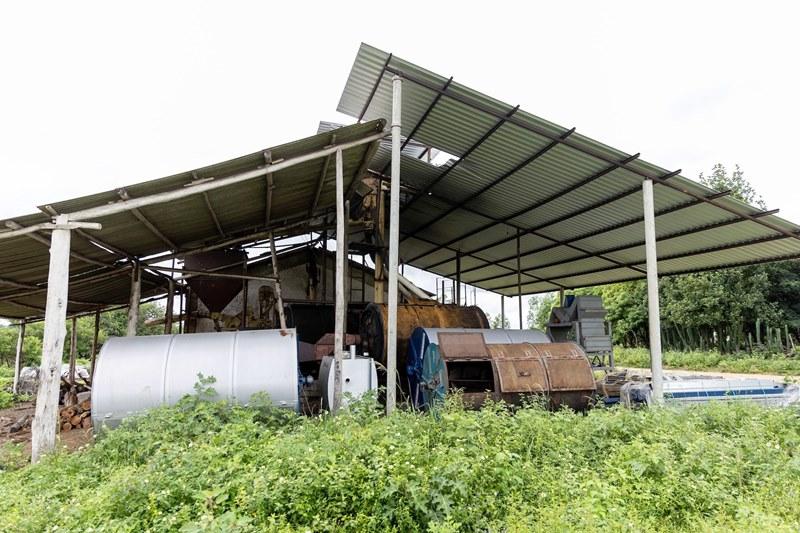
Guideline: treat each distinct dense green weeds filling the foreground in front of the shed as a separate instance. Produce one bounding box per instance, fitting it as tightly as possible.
[0,397,800,532]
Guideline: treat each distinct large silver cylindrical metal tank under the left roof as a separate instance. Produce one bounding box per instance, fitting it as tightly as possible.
[92,329,299,428]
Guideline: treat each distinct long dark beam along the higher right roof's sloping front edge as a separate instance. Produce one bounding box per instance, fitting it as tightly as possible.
[386,63,800,245]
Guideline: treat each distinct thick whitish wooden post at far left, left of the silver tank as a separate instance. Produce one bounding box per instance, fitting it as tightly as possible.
[31,215,70,463]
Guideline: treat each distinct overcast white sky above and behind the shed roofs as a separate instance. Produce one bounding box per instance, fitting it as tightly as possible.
[0,1,800,324]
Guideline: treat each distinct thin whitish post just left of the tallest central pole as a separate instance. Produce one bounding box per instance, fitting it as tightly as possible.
[332,150,348,413]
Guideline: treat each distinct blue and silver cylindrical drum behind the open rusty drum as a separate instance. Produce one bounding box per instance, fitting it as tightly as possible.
[405,328,550,403]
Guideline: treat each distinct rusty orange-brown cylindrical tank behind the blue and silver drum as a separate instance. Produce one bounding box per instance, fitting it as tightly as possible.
[359,302,489,371]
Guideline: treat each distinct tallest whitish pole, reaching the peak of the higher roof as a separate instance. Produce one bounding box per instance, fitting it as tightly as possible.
[386,76,403,415]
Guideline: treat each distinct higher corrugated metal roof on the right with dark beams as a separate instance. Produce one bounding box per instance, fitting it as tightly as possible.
[338,44,800,295]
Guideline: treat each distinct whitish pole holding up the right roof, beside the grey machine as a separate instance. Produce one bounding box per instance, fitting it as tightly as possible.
[642,180,664,404]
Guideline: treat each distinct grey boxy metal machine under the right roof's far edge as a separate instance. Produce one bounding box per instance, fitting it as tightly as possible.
[547,295,614,369]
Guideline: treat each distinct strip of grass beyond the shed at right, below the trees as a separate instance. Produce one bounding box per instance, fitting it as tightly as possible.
[614,347,800,376]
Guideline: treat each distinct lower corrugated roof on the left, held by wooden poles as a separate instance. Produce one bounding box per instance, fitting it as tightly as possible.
[0,119,385,318]
